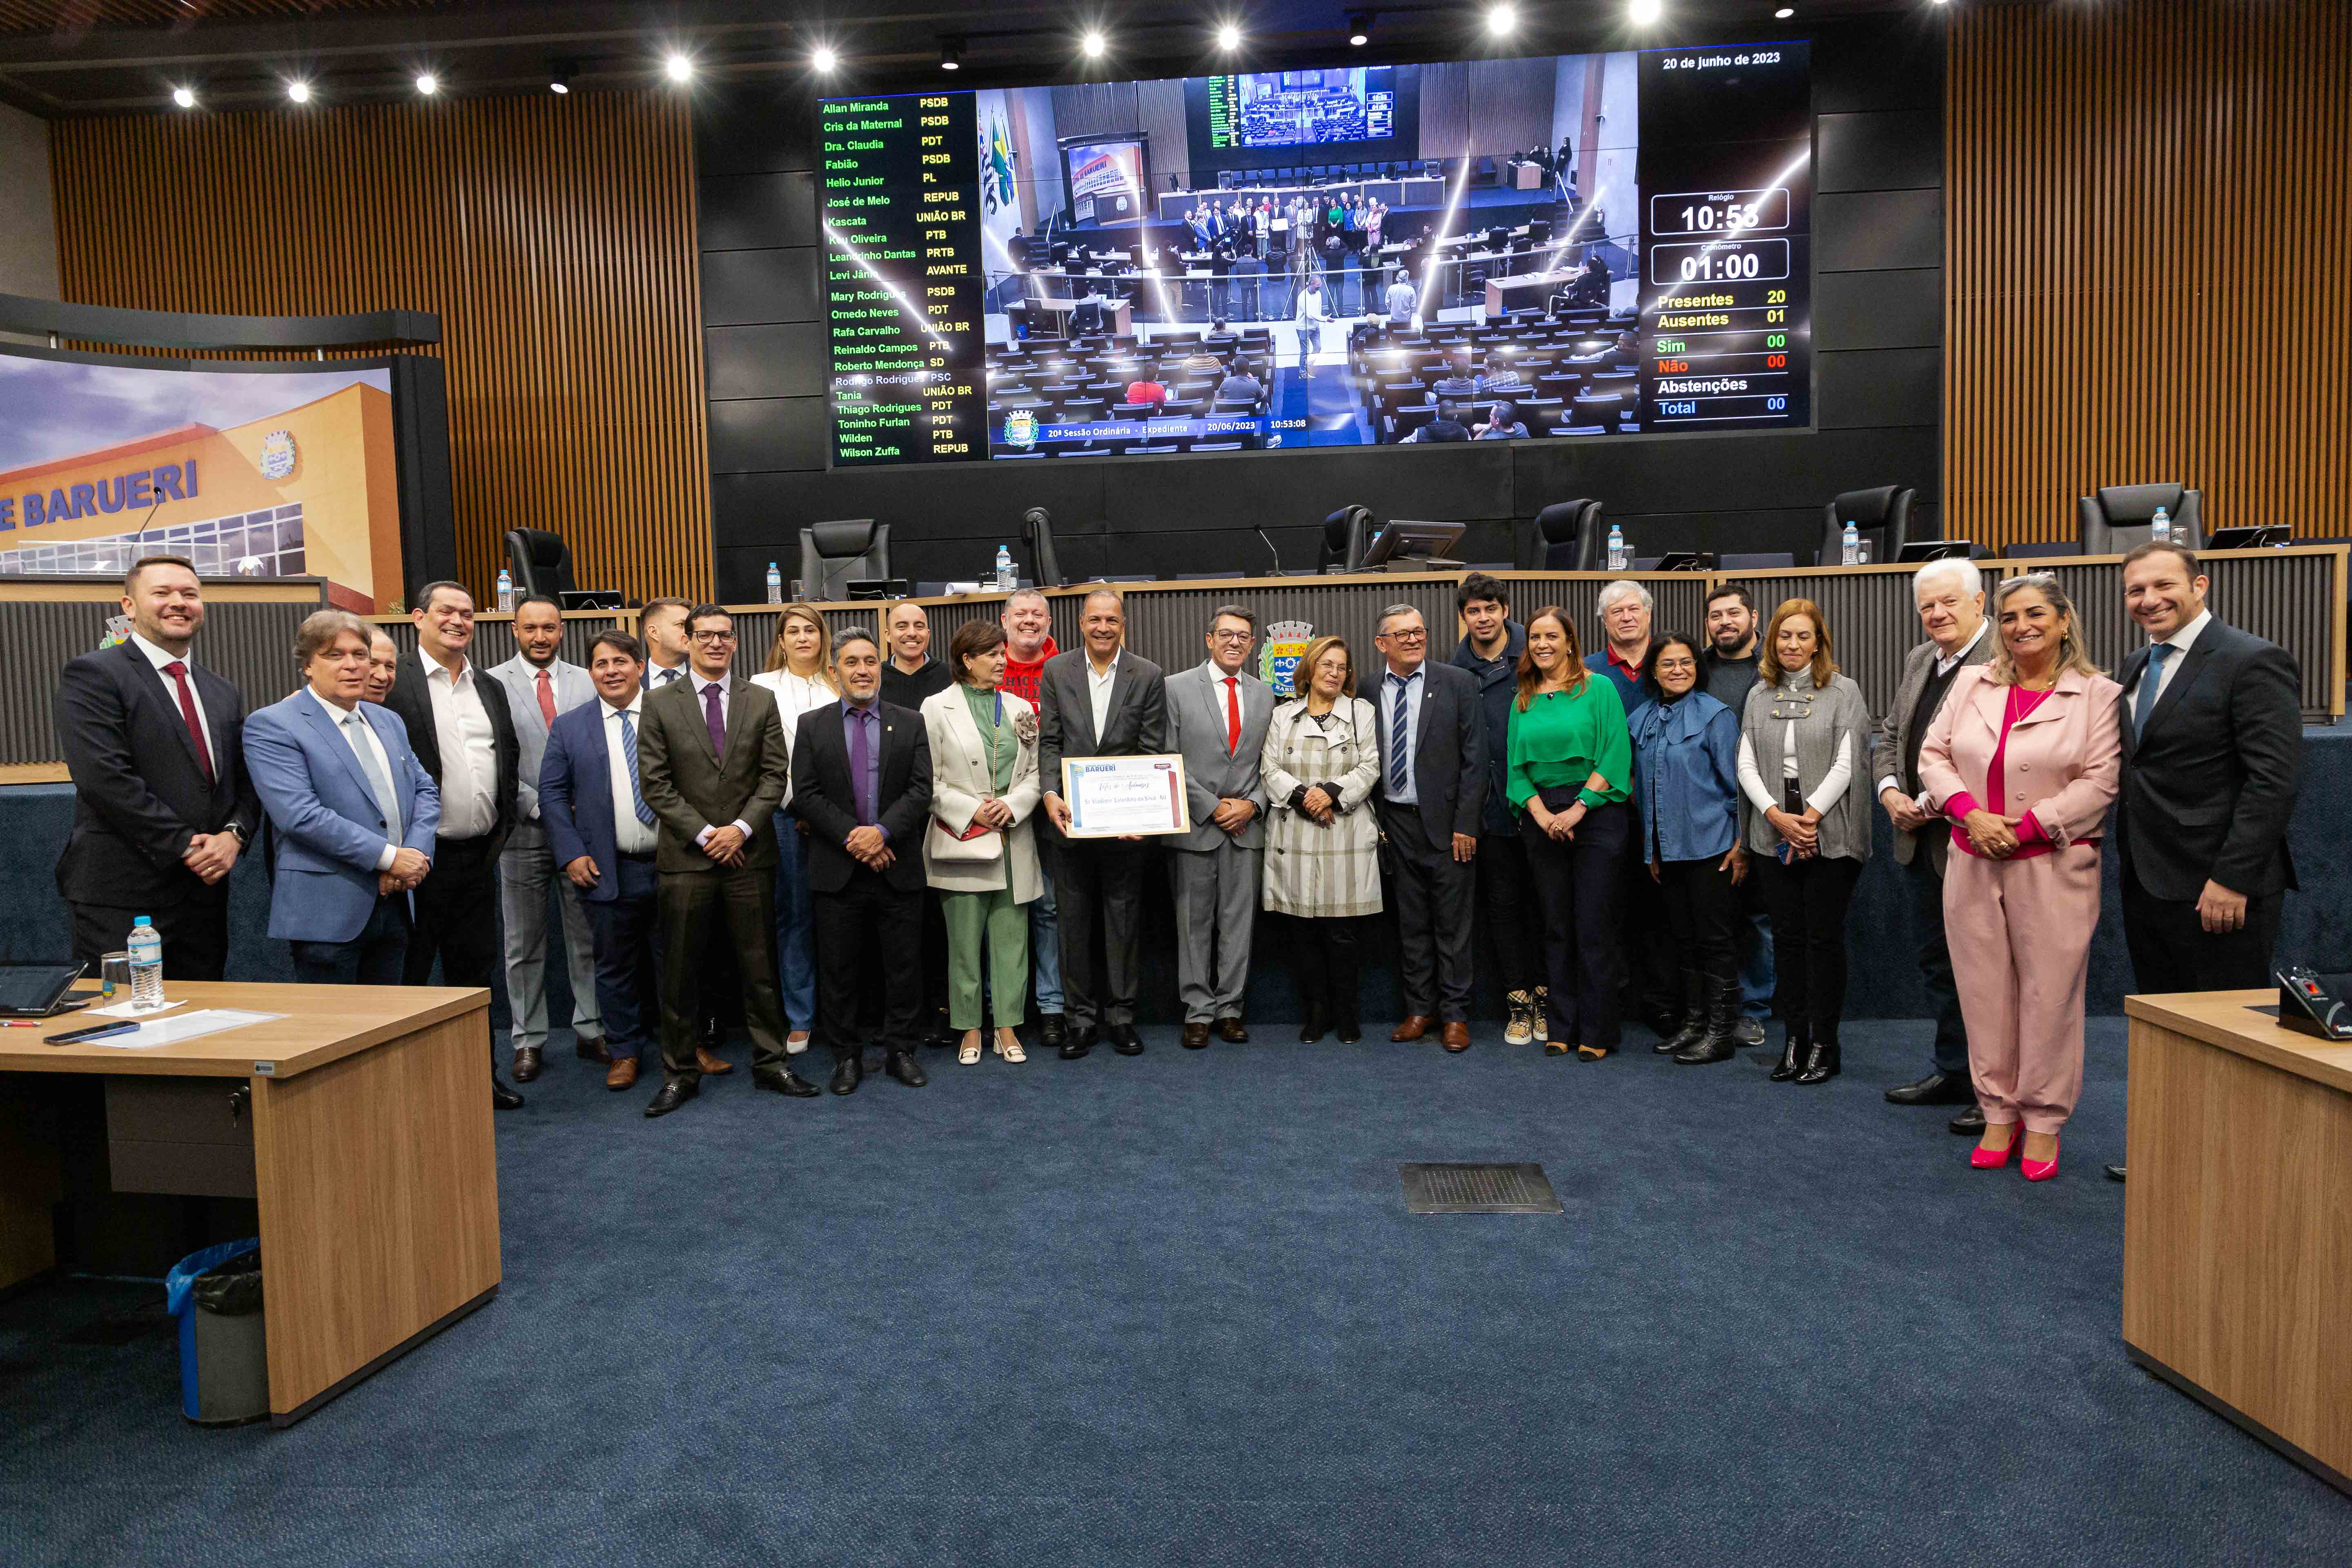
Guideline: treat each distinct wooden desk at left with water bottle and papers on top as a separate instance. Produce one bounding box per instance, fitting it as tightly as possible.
[0,982,499,1427]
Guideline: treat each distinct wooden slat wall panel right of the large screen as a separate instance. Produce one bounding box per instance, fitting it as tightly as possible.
[1943,0,2352,548]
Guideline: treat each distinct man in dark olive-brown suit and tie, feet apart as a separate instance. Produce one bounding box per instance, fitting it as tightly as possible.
[637,604,816,1117]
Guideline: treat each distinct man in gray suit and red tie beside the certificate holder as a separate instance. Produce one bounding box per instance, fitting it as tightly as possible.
[1169,604,1275,1051]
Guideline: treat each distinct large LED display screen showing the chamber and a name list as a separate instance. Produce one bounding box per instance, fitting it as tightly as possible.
[818,42,1813,466]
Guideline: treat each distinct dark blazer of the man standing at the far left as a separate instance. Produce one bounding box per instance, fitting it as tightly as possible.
[52,642,261,907]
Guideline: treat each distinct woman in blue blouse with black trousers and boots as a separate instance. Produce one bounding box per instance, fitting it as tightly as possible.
[1628,633,1748,1067]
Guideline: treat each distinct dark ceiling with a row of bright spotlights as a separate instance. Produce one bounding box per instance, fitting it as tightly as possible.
[0,0,1983,118]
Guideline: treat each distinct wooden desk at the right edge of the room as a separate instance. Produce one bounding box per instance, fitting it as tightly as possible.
[2124,992,2352,1493]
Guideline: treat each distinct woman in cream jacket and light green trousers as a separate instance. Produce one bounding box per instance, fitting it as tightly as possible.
[922,621,1044,1067]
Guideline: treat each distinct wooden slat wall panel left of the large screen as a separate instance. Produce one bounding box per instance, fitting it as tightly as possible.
[52,94,710,602]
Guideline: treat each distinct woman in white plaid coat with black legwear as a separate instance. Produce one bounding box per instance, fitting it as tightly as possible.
[1258,637,1381,1044]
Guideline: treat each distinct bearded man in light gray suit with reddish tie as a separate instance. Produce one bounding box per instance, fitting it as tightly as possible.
[489,595,612,1084]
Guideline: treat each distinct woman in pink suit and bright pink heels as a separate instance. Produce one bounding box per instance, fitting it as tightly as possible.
[1919,571,2122,1183]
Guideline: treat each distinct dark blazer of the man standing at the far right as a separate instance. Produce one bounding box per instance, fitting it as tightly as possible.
[2114,621,2303,903]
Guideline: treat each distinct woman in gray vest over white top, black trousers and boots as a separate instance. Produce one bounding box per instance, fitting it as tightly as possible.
[1740,599,1872,1084]
